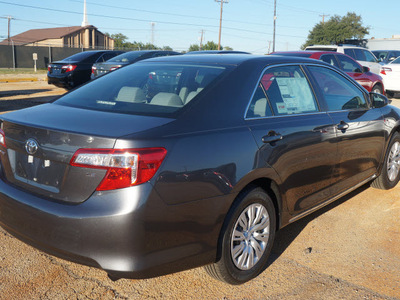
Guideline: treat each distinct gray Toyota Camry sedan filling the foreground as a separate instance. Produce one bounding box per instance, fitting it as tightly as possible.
[0,54,400,284]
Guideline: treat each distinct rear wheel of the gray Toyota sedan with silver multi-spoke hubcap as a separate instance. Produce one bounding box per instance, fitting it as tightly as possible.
[204,187,276,285]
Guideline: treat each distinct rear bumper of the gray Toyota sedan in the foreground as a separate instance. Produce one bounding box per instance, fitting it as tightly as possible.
[0,180,225,278]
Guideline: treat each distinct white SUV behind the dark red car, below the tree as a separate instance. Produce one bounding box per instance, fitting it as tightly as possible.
[305,45,381,74]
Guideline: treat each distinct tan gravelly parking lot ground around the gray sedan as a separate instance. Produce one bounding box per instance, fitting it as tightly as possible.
[0,78,400,299]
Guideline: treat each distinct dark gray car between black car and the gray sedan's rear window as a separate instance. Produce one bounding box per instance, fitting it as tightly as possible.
[91,50,181,79]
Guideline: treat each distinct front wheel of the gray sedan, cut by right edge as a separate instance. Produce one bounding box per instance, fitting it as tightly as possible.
[371,132,400,190]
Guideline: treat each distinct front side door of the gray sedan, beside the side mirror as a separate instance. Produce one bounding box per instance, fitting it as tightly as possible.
[308,66,385,195]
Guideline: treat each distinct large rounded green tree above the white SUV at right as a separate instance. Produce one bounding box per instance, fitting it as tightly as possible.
[301,12,369,49]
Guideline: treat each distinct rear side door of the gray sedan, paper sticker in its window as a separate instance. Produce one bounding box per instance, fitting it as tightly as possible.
[246,65,337,215]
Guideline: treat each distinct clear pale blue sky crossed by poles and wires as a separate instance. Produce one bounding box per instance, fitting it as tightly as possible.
[0,0,400,54]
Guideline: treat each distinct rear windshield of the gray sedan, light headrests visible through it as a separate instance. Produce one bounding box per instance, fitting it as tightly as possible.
[54,62,227,117]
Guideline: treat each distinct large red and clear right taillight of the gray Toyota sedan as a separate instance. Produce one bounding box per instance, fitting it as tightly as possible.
[70,148,167,191]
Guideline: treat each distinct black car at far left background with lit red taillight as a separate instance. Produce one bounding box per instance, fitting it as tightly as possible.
[47,50,124,90]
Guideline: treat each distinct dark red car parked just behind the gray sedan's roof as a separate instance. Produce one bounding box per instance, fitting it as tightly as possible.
[271,51,385,94]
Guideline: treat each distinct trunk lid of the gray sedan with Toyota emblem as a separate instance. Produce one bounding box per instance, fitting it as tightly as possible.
[0,104,171,203]
